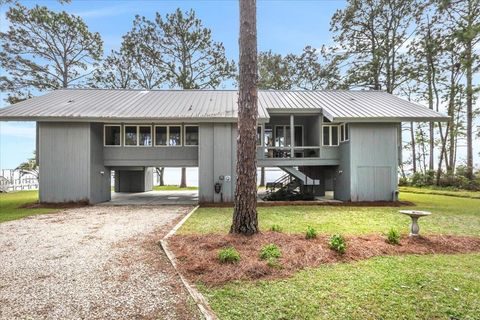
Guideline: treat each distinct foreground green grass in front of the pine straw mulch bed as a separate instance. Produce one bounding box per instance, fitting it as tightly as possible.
[200,254,480,319]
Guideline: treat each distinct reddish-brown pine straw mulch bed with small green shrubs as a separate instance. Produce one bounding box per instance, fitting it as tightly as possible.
[168,232,480,286]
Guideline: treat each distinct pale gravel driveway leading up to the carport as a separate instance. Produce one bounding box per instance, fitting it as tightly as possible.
[0,206,199,319]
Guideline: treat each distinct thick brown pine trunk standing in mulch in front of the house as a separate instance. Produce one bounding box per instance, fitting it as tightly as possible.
[230,0,258,235]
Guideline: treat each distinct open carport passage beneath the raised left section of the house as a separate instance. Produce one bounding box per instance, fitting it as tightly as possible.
[110,167,198,205]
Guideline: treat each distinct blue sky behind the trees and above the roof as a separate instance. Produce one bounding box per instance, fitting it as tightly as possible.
[0,0,480,169]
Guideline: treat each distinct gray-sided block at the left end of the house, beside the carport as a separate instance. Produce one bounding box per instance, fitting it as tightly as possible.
[38,122,110,203]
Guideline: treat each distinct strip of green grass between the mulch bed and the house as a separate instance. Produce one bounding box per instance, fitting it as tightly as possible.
[179,192,480,236]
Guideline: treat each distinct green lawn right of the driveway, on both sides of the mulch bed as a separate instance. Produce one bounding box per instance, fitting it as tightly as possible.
[179,190,480,319]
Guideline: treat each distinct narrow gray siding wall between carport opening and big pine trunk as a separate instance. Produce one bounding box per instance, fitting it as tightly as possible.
[198,123,236,202]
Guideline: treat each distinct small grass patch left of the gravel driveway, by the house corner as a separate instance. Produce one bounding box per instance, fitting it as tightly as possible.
[0,190,59,222]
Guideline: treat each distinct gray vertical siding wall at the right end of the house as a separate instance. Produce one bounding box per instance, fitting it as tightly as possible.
[350,123,398,201]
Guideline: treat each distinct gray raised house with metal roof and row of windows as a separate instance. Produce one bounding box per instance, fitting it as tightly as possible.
[0,89,449,203]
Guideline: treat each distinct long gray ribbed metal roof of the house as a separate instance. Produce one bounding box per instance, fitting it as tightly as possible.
[0,89,449,122]
